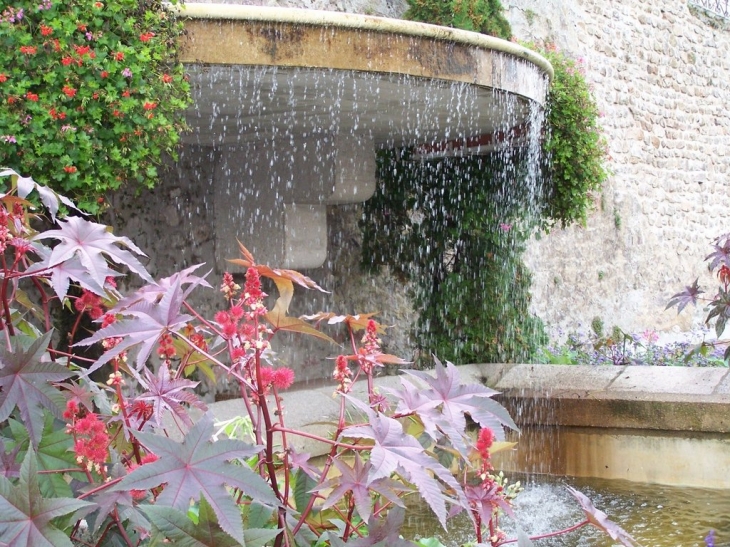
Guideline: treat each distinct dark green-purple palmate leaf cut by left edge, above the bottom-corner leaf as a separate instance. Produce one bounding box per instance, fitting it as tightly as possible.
[0,331,75,448]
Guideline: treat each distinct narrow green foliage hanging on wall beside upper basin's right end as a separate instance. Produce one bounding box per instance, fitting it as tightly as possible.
[540,46,608,227]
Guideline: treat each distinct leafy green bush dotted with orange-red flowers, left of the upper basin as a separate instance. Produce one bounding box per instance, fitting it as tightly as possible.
[0,0,189,211]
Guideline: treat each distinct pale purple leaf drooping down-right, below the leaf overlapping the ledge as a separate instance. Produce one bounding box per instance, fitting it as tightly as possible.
[342,396,460,528]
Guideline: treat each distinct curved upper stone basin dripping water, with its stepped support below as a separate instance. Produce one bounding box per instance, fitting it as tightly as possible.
[173,4,552,269]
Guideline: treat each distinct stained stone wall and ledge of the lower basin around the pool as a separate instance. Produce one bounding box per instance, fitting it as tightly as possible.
[210,364,730,488]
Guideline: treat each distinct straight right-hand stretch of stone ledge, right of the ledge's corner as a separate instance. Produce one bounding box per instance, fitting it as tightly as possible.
[482,365,730,433]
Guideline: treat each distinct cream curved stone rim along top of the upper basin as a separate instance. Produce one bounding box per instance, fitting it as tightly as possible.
[174,3,554,79]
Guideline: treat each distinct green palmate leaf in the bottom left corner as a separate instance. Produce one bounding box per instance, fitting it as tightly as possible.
[0,450,93,547]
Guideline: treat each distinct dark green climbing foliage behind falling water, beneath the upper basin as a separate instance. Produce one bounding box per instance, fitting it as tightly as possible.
[361,151,545,363]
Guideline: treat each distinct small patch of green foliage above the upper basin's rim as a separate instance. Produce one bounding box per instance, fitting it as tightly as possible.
[405,0,512,40]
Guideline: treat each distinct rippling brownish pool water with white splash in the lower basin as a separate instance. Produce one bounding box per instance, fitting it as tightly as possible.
[405,477,730,547]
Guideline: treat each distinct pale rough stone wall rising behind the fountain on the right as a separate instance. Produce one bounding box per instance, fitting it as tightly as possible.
[504,0,730,338]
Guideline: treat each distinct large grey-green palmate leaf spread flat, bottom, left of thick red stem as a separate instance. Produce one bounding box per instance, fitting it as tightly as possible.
[113,414,278,543]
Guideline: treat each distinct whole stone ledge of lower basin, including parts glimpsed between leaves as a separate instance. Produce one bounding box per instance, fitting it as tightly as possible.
[205,364,730,455]
